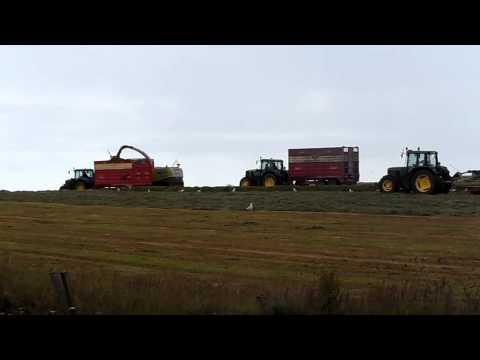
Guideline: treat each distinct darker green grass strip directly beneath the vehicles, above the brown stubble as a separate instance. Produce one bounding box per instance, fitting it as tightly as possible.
[0,189,480,216]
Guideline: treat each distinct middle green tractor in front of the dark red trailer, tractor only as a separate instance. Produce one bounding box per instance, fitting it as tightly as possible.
[240,158,288,187]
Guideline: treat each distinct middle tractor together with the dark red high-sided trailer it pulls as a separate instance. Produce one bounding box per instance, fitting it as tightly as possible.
[240,146,360,187]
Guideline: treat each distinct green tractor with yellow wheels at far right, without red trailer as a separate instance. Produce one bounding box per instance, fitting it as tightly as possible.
[379,148,452,194]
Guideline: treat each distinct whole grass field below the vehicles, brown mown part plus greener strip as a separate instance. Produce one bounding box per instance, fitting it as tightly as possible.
[0,191,480,313]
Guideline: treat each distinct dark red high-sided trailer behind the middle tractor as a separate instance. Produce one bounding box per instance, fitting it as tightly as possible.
[288,146,360,185]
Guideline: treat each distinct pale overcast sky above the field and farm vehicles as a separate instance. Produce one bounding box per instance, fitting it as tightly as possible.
[0,45,480,191]
